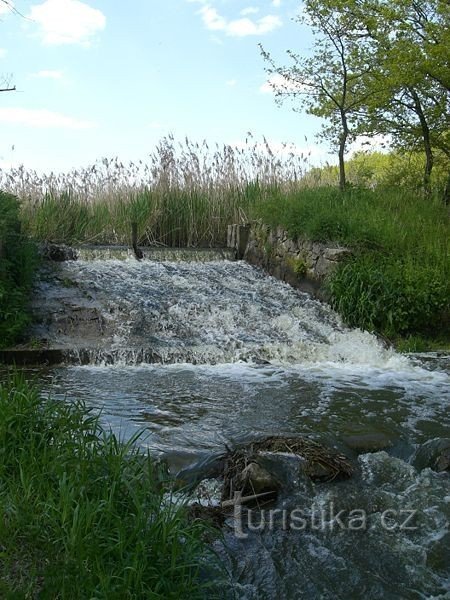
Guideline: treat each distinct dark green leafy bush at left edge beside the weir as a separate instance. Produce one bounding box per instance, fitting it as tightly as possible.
[0,191,37,348]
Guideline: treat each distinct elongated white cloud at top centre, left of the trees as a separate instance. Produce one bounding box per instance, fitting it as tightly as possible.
[199,5,282,37]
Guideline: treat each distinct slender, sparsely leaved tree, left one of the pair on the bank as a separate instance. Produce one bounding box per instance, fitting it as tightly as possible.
[260,0,378,190]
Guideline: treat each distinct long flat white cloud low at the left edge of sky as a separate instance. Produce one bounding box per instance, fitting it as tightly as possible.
[0,108,95,129]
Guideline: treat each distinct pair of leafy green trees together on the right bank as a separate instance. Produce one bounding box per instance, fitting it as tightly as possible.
[262,0,450,202]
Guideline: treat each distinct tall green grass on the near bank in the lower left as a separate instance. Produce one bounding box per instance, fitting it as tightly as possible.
[0,376,221,600]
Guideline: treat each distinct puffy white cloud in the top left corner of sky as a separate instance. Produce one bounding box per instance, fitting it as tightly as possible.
[28,0,106,46]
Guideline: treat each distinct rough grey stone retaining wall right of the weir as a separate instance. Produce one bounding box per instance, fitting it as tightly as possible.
[227,223,351,299]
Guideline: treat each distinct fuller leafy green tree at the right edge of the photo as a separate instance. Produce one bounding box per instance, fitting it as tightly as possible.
[353,0,450,193]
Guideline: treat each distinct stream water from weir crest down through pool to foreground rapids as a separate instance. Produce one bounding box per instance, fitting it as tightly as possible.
[35,251,450,600]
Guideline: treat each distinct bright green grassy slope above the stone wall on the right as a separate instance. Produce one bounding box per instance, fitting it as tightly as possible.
[254,187,450,340]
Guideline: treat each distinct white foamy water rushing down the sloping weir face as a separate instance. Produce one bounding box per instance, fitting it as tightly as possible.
[33,259,448,371]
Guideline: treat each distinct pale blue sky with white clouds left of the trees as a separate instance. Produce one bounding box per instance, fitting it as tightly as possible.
[0,0,334,172]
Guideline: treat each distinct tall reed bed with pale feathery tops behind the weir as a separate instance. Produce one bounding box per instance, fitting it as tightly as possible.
[0,136,308,247]
